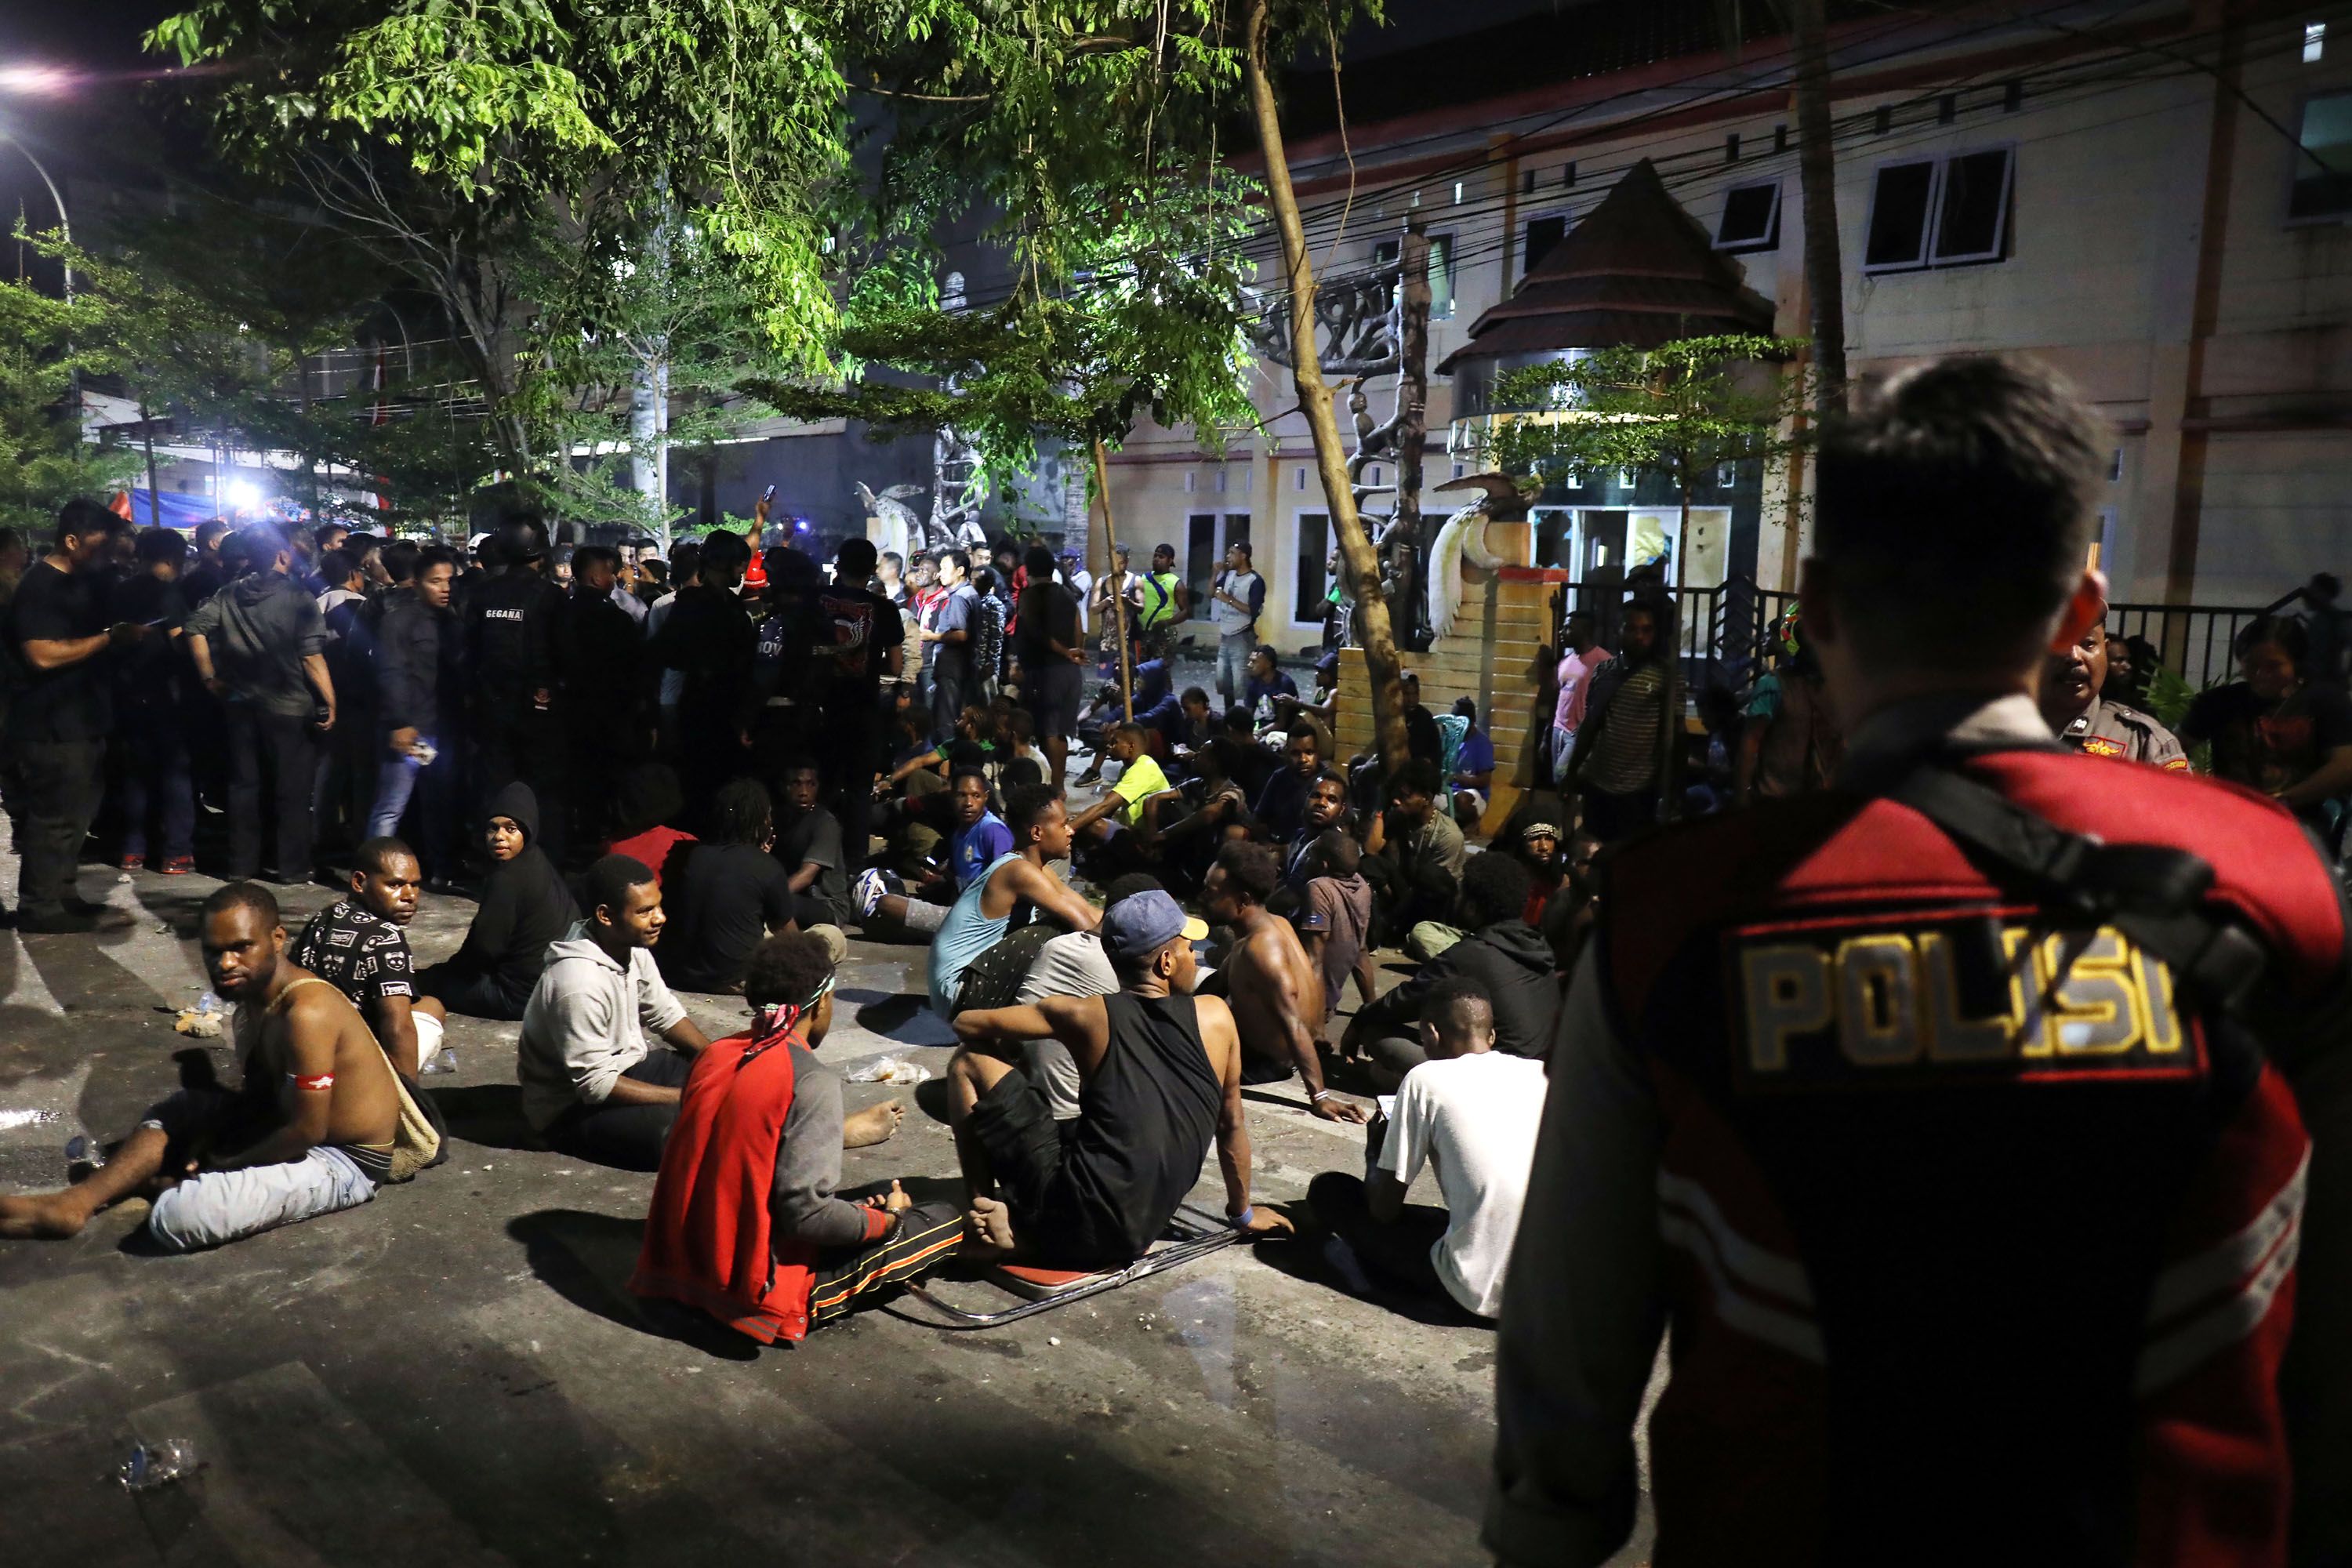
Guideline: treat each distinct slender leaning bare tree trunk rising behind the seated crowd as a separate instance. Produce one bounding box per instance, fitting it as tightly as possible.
[1242,0,1409,771]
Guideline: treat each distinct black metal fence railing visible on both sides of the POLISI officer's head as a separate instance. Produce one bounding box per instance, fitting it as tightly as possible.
[1555,574,2296,691]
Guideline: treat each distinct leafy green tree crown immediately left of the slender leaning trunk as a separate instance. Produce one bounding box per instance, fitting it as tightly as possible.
[757,0,1256,485]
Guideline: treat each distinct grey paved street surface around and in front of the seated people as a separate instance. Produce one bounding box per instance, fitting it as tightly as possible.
[0,858,1632,1568]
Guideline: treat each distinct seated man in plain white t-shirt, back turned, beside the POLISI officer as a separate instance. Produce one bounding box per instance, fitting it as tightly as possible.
[1308,975,1545,1316]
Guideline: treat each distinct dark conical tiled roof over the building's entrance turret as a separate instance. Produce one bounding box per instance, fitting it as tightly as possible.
[1437,158,1773,374]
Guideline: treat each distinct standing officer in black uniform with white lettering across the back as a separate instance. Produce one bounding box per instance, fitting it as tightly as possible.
[463,508,567,862]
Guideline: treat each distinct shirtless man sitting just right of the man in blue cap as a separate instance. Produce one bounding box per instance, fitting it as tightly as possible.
[1200,844,1367,1121]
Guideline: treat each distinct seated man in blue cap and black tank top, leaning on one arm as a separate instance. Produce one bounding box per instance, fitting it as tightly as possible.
[948,891,1291,1269]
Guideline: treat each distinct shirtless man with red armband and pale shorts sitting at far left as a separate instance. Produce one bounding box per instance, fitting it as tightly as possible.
[0,881,400,1253]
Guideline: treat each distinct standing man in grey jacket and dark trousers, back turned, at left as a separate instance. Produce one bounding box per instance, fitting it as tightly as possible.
[183,527,334,881]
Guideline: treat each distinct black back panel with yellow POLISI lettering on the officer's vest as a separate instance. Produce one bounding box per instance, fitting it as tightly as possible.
[1724,905,2206,1093]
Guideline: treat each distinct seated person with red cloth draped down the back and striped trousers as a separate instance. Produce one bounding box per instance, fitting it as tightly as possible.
[628,931,964,1342]
